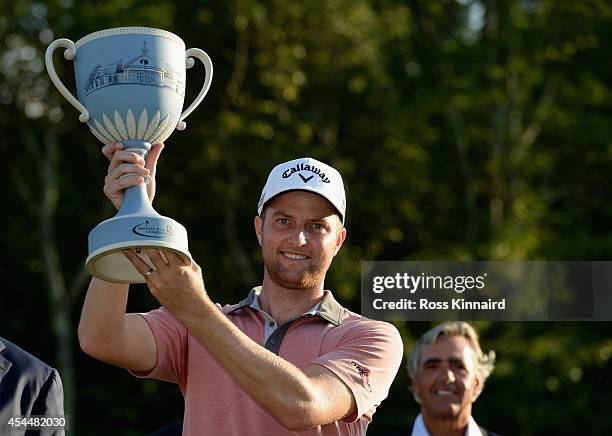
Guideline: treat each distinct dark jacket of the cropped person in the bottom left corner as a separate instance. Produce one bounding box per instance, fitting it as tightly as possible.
[0,337,64,435]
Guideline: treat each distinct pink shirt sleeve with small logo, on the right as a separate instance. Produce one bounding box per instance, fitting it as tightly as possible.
[313,320,403,422]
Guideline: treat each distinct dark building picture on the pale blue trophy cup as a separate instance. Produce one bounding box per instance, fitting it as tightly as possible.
[85,41,185,97]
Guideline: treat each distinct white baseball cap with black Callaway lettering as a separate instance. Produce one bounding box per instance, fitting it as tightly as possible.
[257,157,346,224]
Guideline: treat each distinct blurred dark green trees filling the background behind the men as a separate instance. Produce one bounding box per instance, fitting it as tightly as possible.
[0,0,612,435]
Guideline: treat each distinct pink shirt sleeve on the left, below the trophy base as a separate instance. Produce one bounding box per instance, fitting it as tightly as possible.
[130,306,188,390]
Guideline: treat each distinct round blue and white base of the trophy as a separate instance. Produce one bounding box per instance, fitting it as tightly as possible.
[85,210,191,283]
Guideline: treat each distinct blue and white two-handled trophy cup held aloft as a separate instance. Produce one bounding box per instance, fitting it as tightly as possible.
[45,27,213,283]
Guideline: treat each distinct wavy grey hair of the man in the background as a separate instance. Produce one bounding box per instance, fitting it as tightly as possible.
[408,321,495,403]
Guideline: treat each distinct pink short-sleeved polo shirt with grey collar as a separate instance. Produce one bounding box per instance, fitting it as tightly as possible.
[133,288,403,436]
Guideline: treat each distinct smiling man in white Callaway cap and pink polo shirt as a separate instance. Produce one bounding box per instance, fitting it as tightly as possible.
[79,143,402,435]
